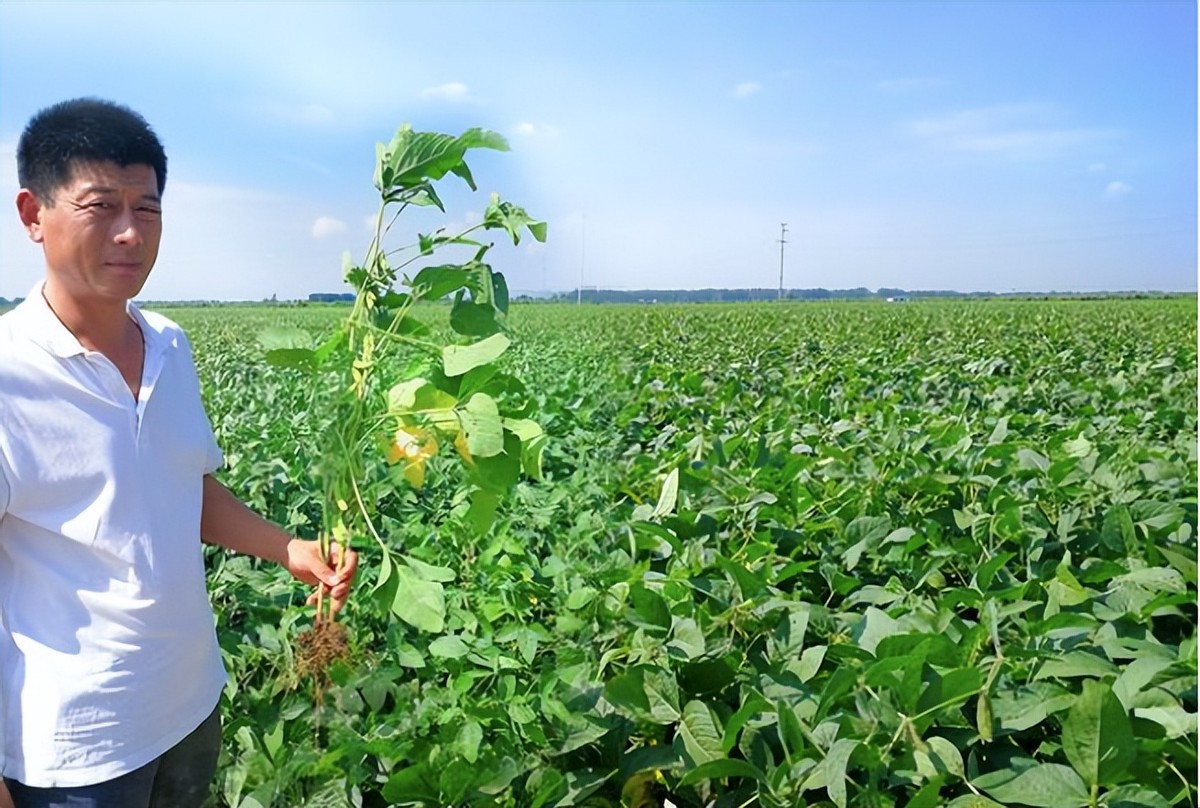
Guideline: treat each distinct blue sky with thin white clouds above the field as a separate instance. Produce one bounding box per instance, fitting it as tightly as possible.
[0,0,1198,299]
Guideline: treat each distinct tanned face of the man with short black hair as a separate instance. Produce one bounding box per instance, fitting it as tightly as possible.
[17,162,162,303]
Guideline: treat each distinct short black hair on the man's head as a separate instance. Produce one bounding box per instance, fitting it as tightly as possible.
[17,98,167,203]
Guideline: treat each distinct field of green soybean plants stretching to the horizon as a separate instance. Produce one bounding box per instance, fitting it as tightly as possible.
[174,297,1196,808]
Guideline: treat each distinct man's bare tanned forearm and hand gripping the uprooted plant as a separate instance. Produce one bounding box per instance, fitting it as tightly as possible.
[200,474,359,612]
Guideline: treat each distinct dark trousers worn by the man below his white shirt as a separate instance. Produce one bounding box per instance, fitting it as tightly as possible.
[5,708,221,808]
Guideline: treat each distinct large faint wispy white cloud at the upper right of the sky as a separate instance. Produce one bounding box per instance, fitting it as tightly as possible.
[908,103,1121,158]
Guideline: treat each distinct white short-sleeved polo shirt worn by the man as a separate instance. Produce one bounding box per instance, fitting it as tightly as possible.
[0,285,226,786]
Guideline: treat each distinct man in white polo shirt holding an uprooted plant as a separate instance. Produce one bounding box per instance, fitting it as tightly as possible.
[0,98,358,808]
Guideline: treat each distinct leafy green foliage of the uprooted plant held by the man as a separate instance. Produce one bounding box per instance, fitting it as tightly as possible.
[259,124,546,581]
